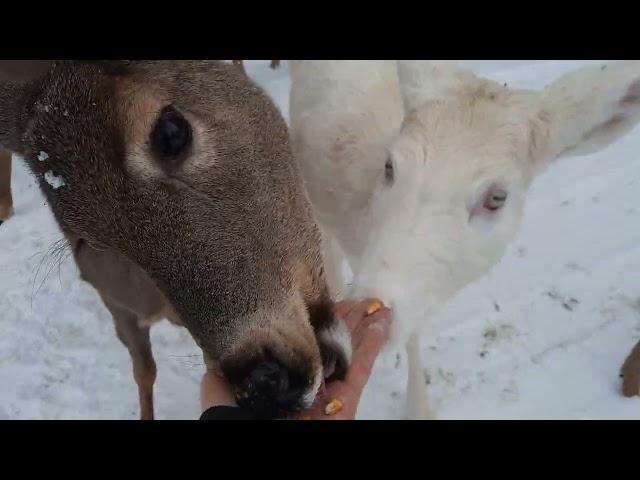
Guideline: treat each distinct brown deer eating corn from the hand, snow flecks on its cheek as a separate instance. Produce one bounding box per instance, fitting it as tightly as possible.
[0,61,350,419]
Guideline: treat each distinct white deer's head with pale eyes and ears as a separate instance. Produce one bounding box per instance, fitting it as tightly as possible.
[355,61,640,342]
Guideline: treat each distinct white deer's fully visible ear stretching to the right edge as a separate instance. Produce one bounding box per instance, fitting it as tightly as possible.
[531,60,640,161]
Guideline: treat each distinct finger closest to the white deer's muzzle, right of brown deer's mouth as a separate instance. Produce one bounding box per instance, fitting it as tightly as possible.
[346,319,390,392]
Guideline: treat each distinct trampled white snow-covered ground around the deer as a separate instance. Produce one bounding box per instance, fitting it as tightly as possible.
[0,61,640,419]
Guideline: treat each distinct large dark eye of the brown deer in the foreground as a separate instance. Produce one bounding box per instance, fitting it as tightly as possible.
[151,105,193,164]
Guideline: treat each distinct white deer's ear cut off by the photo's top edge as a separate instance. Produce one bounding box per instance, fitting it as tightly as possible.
[398,60,471,113]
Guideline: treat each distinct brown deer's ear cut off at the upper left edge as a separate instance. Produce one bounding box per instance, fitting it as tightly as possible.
[0,60,53,154]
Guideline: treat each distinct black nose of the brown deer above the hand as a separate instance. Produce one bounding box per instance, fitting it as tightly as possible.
[238,360,309,418]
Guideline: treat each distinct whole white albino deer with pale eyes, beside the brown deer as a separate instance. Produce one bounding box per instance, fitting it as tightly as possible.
[290,60,640,419]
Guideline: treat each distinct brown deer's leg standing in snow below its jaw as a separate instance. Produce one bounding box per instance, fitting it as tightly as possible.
[105,302,156,420]
